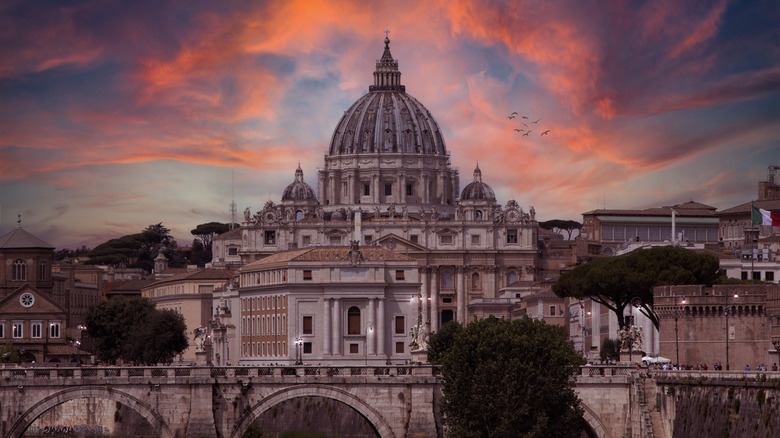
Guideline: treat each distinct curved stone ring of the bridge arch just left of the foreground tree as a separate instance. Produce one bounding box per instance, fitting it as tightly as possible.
[230,385,395,438]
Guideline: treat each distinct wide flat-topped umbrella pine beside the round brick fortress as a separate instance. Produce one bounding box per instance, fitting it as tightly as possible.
[552,246,720,328]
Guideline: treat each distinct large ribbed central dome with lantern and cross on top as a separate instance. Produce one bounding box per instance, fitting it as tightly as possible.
[330,38,447,156]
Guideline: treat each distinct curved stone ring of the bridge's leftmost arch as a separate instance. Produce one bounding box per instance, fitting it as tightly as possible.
[8,386,173,438]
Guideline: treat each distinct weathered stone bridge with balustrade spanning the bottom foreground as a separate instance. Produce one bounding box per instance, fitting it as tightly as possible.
[6,365,780,438]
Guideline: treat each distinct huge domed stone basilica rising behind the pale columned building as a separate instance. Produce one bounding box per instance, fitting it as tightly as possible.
[212,38,545,346]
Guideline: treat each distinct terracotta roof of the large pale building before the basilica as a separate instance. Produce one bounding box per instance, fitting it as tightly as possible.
[244,246,415,268]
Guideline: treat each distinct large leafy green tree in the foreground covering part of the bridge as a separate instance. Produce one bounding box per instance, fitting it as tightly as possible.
[431,317,585,438]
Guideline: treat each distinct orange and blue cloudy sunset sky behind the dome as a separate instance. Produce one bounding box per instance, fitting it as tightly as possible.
[0,0,780,248]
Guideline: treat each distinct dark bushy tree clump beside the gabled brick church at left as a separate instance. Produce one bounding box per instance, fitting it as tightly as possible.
[86,297,189,365]
